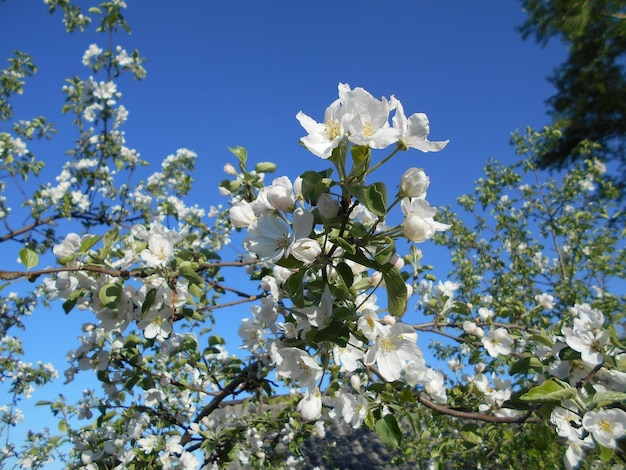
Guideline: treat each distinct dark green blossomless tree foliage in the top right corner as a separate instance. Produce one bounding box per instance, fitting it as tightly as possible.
[520,0,626,191]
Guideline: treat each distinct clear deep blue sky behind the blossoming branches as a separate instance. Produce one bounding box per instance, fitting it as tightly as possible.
[0,0,564,462]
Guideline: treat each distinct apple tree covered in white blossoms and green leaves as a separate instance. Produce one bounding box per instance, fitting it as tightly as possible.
[0,0,626,469]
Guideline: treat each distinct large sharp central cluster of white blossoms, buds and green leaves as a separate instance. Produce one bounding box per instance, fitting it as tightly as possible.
[223,84,449,427]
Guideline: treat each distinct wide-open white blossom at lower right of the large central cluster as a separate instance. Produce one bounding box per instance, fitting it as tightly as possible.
[364,323,423,382]
